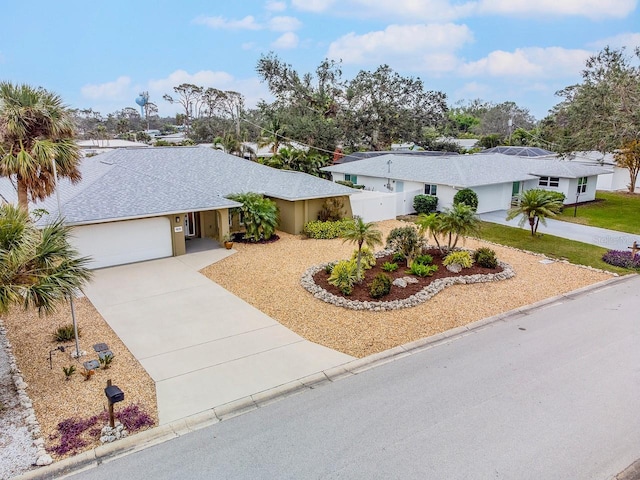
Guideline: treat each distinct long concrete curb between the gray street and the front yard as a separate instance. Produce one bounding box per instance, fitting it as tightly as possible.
[14,274,640,480]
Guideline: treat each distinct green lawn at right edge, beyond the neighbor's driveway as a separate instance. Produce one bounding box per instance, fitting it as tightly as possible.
[556,191,640,234]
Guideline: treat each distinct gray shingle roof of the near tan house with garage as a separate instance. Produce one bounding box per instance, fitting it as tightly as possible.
[0,147,354,224]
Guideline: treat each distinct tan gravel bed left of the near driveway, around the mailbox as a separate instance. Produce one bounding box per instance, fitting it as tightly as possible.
[0,298,158,463]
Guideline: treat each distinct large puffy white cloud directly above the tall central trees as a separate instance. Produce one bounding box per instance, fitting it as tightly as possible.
[327,23,473,66]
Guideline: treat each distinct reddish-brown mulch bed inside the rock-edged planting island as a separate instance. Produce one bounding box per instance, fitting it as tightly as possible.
[313,250,502,302]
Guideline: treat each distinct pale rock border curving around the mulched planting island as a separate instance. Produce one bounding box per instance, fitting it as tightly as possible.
[300,250,516,312]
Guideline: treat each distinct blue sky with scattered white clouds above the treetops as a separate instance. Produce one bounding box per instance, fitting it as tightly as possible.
[0,0,640,119]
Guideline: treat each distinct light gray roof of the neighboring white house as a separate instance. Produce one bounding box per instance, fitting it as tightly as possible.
[323,154,607,188]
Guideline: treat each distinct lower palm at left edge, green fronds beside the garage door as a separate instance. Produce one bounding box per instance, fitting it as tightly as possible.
[0,204,91,314]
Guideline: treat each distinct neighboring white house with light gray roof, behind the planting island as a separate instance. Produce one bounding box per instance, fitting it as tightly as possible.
[323,154,606,215]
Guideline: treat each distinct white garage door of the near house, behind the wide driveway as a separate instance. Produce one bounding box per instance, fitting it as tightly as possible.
[72,217,173,268]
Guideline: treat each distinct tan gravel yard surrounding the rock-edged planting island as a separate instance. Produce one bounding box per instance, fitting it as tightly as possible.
[202,220,611,357]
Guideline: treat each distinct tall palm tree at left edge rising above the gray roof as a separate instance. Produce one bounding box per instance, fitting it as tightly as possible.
[0,82,80,211]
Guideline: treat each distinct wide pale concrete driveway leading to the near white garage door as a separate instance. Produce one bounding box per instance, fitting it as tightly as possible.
[85,249,353,424]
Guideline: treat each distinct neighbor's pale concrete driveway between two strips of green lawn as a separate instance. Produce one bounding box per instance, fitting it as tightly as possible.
[478,207,640,252]
